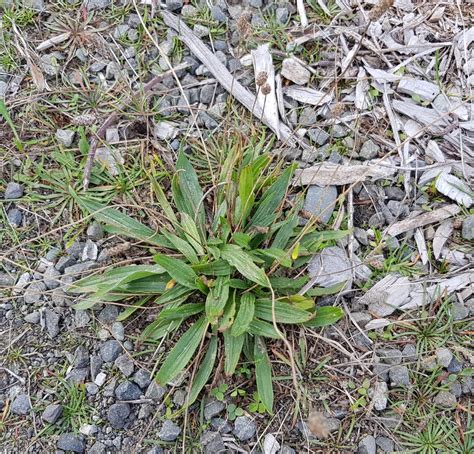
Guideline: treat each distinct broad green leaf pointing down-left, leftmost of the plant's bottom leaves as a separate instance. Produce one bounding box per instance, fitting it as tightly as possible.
[156,317,208,386]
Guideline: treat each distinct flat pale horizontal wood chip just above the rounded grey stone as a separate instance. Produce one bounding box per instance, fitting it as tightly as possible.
[294,159,395,186]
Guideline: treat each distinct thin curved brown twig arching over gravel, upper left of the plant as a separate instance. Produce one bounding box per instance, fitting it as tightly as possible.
[83,63,191,190]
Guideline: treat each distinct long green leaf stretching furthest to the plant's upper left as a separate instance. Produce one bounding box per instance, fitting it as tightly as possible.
[73,198,164,246]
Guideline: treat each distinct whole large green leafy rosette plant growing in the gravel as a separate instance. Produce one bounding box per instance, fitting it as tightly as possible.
[72,152,347,412]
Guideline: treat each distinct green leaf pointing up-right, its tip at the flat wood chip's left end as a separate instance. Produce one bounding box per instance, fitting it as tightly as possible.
[251,165,295,227]
